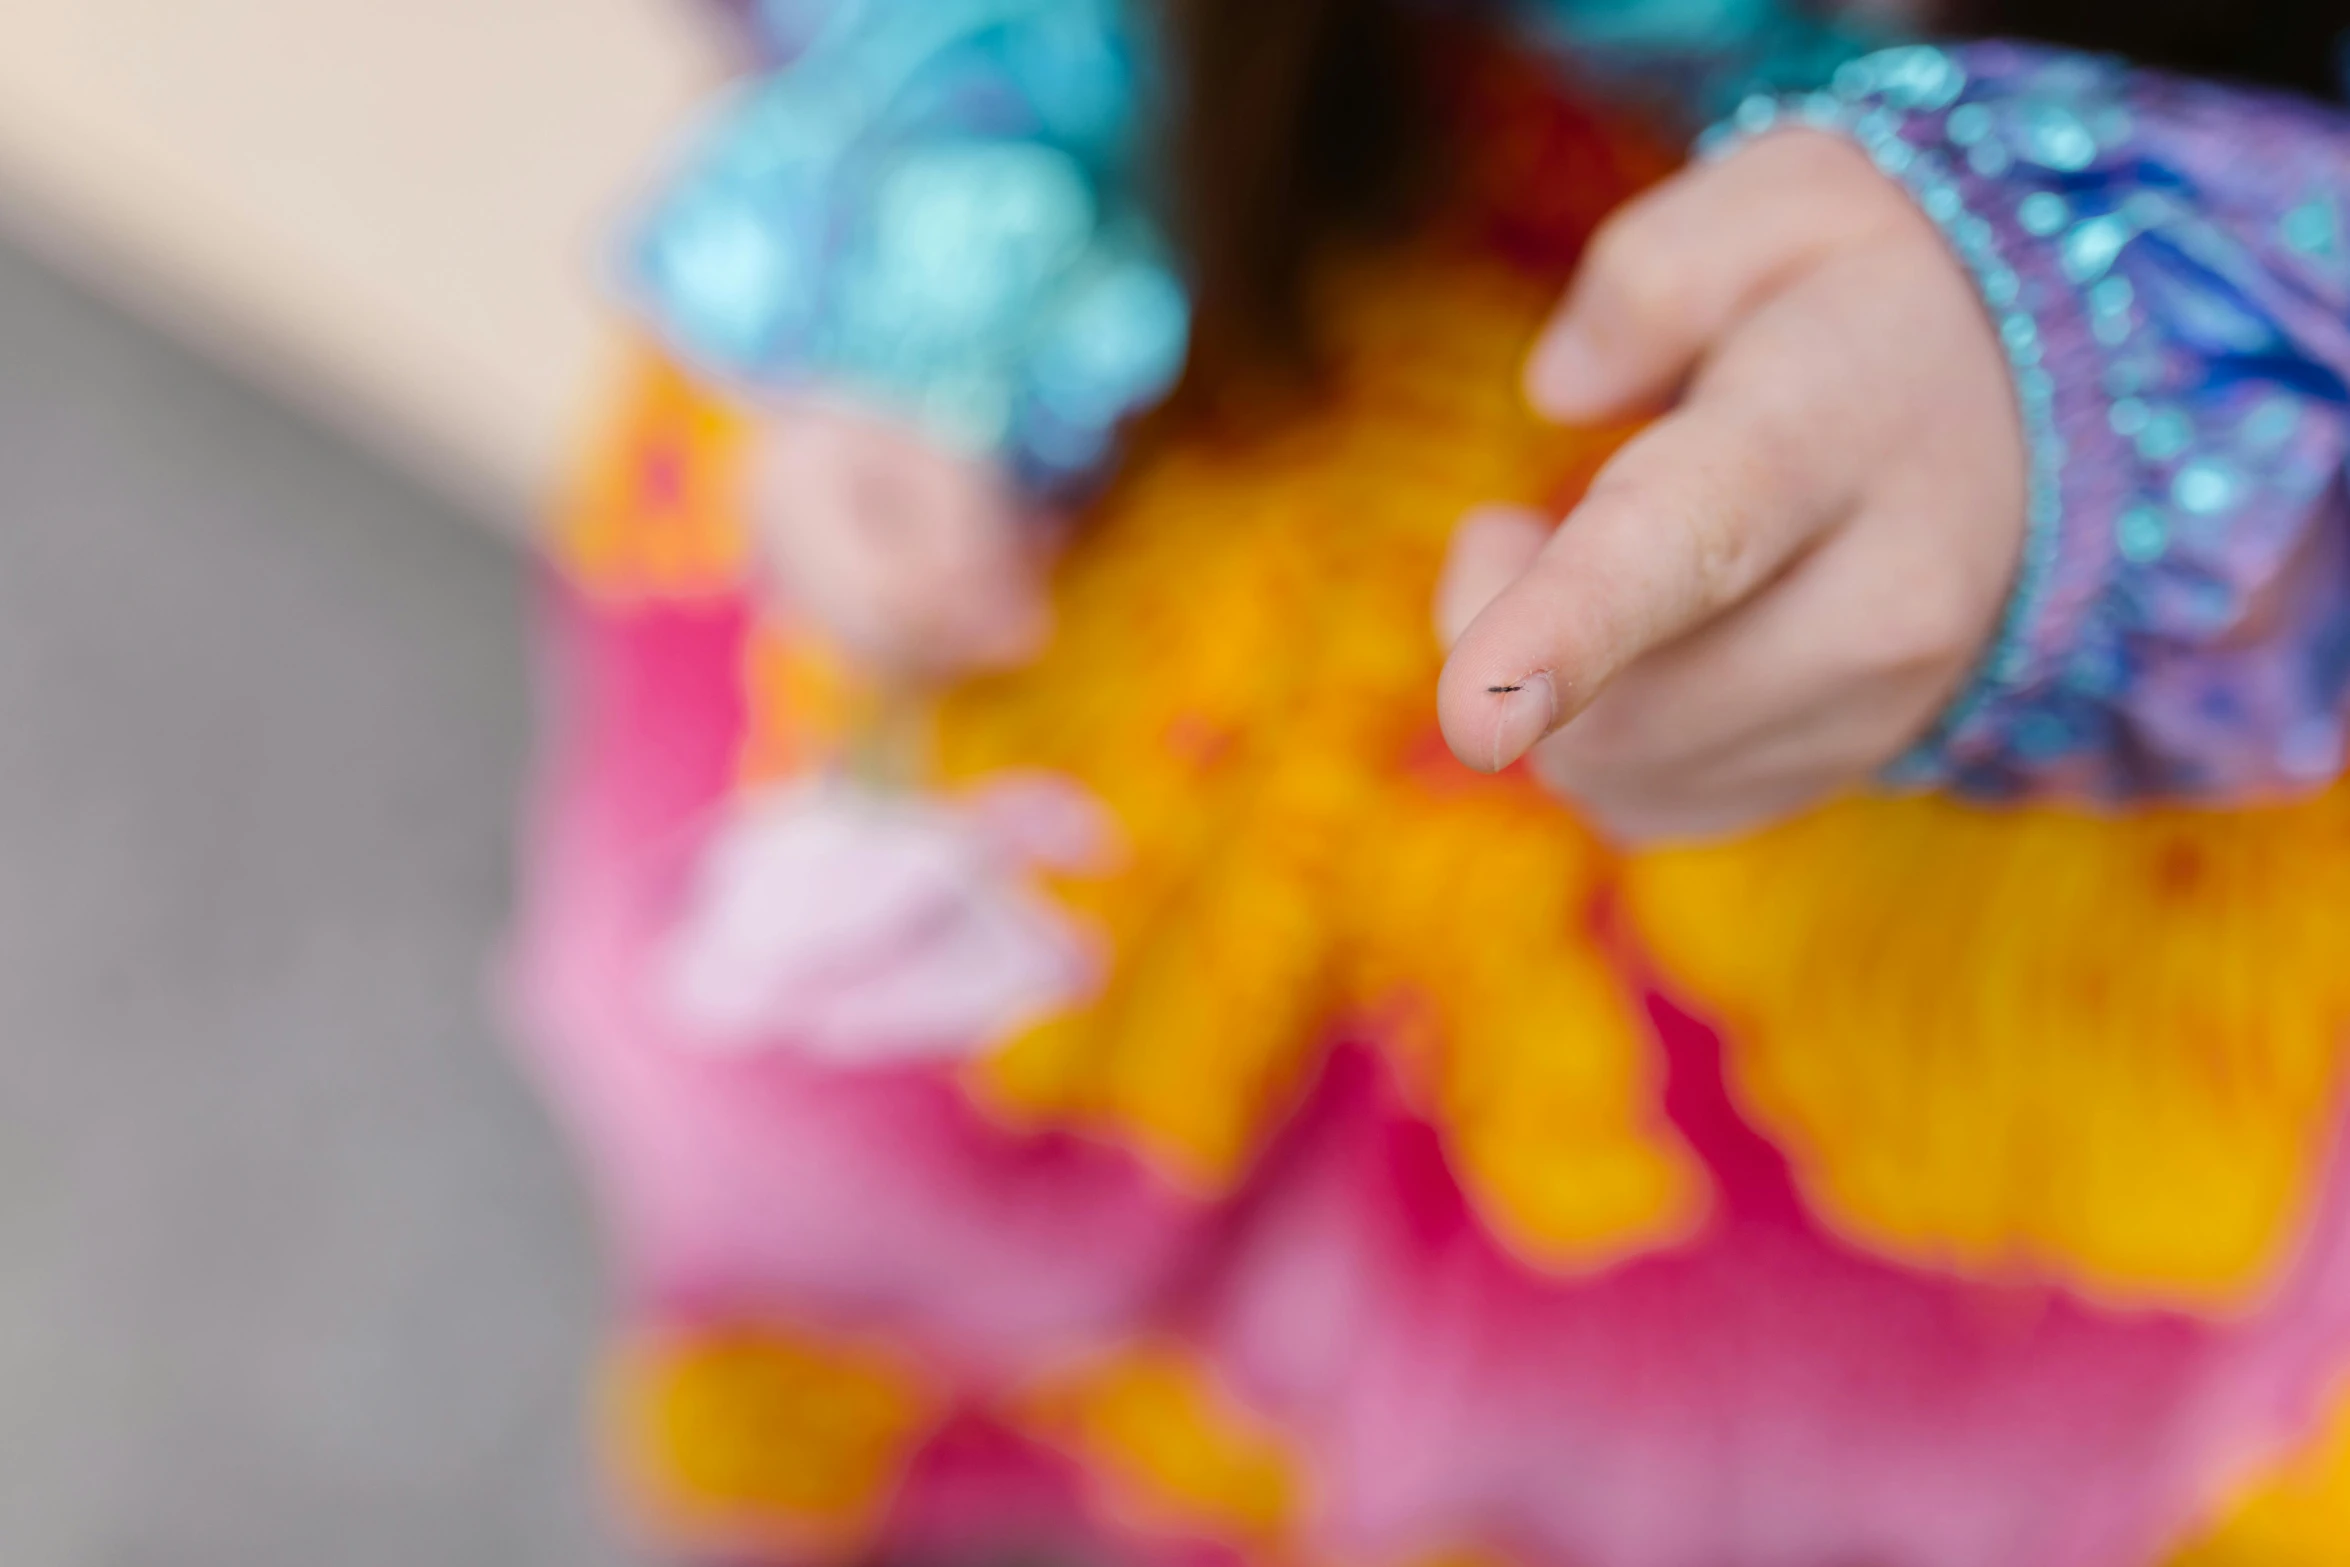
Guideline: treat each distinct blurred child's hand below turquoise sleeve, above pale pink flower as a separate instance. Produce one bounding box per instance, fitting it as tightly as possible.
[757,402,1048,679]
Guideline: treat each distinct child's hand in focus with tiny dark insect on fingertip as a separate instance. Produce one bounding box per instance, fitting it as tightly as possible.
[1438,132,2028,839]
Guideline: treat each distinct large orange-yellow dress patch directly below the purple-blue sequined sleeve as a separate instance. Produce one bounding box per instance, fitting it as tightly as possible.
[1626,789,2350,1311]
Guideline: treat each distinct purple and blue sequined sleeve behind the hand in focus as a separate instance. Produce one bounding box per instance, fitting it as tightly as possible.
[1727,45,2350,799]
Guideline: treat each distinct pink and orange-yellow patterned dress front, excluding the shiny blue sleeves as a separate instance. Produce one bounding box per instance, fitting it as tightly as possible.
[515,66,2350,1567]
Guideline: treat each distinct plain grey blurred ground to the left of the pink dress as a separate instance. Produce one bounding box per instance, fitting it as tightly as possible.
[0,236,634,1567]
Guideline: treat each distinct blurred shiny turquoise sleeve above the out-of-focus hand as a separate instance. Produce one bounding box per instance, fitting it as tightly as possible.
[625,0,1189,491]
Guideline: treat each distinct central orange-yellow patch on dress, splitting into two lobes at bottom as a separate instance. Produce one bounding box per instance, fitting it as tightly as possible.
[938,256,1704,1266]
